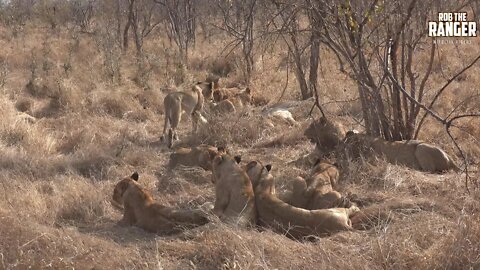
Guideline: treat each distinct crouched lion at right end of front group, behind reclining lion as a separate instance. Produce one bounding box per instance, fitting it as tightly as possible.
[287,160,352,210]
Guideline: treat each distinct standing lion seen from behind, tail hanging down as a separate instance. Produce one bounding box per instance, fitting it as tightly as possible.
[160,82,215,148]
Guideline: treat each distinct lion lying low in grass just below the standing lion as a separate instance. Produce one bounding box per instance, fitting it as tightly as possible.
[167,144,226,171]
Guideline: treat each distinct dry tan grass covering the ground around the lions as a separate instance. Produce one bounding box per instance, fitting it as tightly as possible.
[0,25,480,269]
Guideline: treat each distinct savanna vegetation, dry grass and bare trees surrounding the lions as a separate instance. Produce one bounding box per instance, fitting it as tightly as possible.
[0,0,480,269]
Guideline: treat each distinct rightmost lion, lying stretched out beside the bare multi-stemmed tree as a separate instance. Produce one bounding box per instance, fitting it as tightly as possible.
[345,132,460,173]
